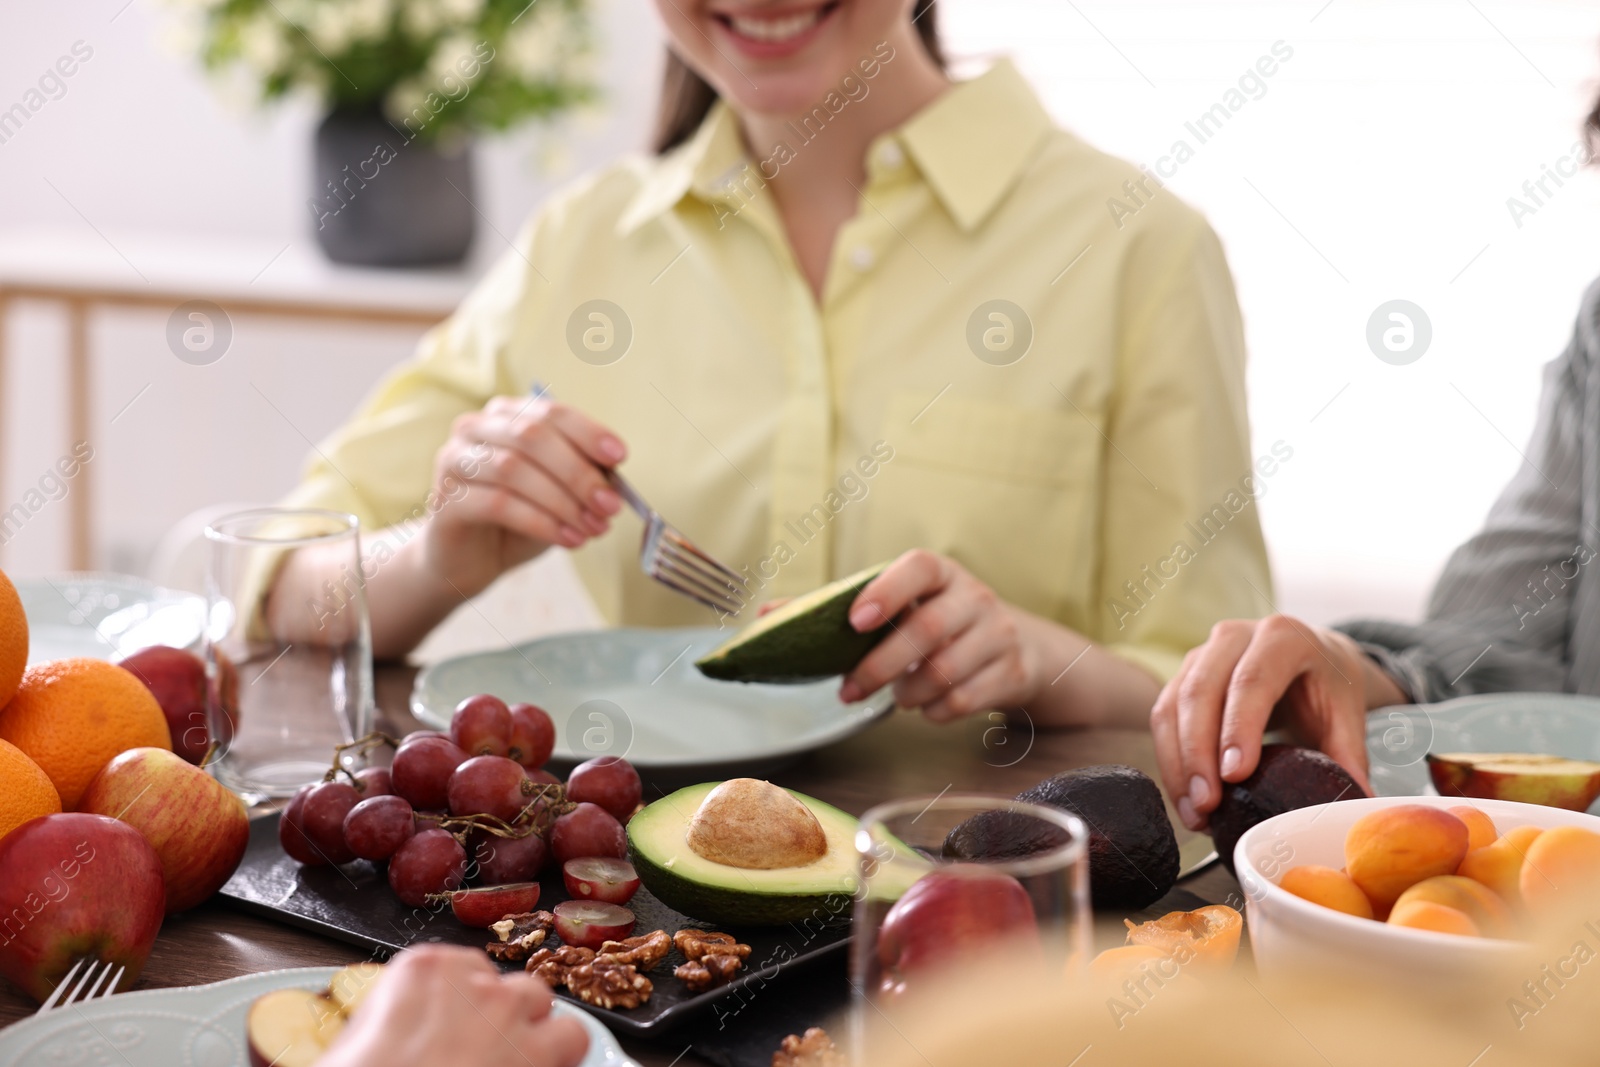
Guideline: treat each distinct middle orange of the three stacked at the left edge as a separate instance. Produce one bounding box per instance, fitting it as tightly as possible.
[0,659,173,811]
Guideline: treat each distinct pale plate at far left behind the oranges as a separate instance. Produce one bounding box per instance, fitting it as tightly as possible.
[16,573,205,664]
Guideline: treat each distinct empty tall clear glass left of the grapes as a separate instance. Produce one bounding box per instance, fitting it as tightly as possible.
[205,507,373,803]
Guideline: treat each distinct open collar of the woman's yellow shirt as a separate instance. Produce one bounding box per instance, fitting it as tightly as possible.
[619,59,1051,234]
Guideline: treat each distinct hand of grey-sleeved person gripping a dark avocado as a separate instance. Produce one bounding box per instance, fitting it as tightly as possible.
[1150,614,1405,830]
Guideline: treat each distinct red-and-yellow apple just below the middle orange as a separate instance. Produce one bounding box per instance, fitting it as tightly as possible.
[78,749,250,913]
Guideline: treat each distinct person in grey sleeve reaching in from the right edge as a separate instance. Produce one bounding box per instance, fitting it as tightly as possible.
[1150,93,1600,829]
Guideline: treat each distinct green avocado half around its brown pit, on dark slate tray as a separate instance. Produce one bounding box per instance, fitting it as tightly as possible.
[627,782,915,926]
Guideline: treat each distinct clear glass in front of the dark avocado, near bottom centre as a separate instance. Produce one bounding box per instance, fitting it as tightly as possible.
[850,793,1091,1062]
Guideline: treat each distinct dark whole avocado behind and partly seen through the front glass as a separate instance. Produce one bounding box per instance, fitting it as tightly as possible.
[944,763,1178,910]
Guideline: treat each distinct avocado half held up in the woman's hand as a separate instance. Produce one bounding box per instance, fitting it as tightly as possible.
[694,563,890,685]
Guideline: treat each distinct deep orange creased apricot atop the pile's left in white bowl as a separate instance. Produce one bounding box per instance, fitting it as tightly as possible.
[1344,805,1469,912]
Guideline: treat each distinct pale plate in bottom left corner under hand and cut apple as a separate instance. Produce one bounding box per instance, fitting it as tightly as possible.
[0,966,638,1067]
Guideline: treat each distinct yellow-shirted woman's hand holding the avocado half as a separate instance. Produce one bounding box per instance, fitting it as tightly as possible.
[838,549,1040,721]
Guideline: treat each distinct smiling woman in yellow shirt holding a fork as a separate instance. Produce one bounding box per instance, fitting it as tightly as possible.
[269,0,1286,725]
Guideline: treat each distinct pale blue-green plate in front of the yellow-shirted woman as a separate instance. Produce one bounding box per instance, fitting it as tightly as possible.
[411,627,893,771]
